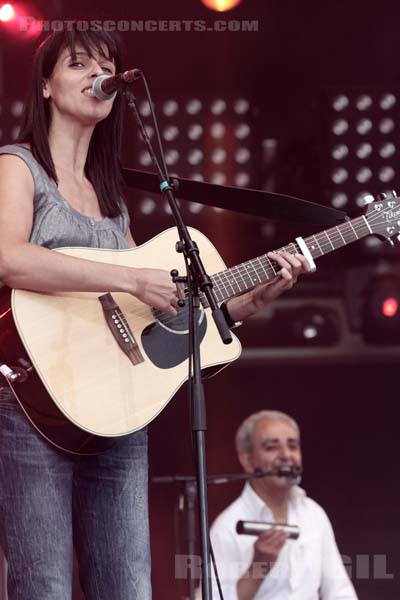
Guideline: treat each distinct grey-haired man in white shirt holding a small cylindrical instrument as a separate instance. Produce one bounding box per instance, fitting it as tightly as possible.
[211,410,357,600]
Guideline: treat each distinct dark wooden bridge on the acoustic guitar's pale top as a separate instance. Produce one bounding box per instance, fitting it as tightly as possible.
[99,293,144,365]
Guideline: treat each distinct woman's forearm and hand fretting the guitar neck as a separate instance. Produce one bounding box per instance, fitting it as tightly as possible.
[227,252,311,321]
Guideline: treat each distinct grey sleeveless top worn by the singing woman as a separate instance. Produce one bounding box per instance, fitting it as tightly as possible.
[0,144,129,250]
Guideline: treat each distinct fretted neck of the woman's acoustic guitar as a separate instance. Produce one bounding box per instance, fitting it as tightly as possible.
[211,215,372,303]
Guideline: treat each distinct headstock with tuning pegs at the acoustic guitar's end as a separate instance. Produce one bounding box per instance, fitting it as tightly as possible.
[365,191,400,241]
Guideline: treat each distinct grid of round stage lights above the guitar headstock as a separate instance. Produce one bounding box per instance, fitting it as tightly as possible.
[325,88,400,212]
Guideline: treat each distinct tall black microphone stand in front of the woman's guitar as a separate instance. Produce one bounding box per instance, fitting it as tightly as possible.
[125,83,232,600]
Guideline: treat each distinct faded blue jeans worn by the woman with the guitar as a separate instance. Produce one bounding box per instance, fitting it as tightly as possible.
[0,388,151,600]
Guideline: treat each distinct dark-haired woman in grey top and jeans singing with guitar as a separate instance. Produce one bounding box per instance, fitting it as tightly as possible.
[0,21,309,600]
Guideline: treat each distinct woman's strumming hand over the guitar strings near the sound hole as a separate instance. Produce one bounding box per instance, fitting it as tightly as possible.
[132,269,179,316]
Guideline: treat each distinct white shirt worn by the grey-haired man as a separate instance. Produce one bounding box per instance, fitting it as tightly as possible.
[210,483,357,600]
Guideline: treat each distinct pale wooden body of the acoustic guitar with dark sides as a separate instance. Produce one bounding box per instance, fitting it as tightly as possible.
[0,229,241,454]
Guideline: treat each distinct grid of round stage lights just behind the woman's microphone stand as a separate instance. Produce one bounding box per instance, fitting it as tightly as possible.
[134,95,258,216]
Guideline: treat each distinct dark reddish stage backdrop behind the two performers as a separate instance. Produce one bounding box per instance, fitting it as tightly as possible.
[0,0,400,600]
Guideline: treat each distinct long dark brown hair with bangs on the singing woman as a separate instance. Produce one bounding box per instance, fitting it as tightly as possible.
[17,24,123,217]
